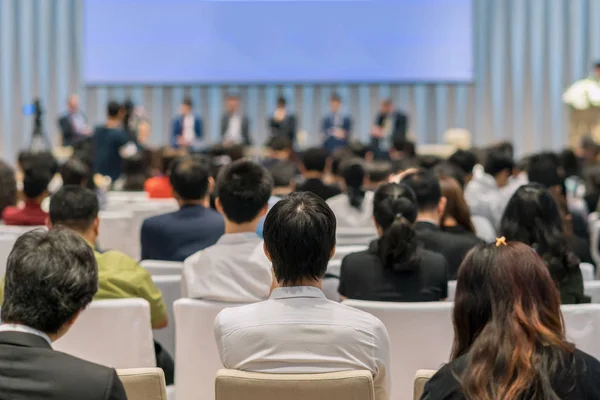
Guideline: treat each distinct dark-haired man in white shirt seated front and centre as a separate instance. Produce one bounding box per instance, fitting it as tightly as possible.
[214,192,390,400]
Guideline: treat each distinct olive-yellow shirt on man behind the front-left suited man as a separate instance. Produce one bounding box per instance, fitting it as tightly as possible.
[0,250,167,326]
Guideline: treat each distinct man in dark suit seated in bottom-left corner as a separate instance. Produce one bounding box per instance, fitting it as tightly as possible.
[0,229,127,400]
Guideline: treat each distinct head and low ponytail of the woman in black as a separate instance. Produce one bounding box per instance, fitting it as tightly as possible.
[373,183,420,272]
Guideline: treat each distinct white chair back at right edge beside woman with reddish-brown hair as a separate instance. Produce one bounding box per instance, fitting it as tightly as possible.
[561,304,600,358]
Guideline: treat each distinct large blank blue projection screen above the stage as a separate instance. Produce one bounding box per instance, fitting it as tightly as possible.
[84,0,473,85]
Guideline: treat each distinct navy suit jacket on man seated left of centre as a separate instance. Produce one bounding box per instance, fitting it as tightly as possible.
[141,205,225,261]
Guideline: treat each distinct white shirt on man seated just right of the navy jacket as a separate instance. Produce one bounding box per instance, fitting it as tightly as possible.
[183,232,273,303]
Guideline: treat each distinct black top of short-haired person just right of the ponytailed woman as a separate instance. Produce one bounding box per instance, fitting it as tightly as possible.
[415,221,482,280]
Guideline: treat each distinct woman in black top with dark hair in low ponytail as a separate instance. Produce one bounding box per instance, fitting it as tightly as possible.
[338,183,448,301]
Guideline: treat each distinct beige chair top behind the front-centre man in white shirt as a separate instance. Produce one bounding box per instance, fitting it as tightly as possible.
[215,369,375,400]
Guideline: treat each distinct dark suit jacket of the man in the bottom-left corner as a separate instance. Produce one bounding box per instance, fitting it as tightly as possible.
[0,332,127,400]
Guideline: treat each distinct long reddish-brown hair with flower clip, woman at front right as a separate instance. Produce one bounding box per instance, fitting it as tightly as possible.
[452,242,575,400]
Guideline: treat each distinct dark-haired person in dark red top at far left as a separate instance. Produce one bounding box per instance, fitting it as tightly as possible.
[2,163,52,226]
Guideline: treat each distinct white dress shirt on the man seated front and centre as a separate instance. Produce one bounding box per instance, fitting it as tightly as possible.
[215,286,390,400]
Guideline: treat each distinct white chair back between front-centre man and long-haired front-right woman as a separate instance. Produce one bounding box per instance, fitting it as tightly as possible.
[344,300,454,399]
